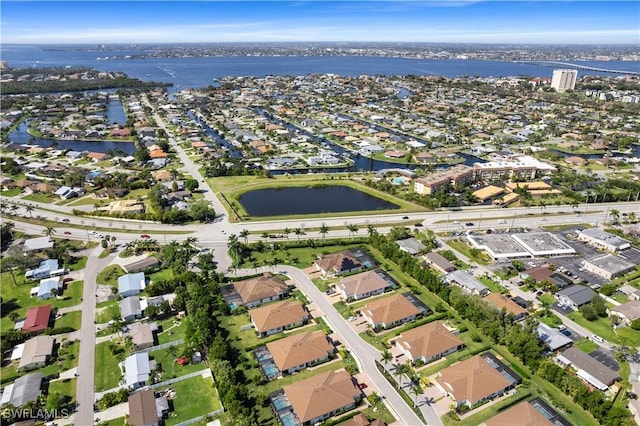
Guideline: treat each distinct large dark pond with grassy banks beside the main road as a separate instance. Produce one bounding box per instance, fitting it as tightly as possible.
[239,185,400,216]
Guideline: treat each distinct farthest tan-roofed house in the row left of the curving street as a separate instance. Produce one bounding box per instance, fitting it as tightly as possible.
[220,273,289,309]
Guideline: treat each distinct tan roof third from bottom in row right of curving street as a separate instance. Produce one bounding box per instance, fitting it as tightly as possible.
[397,321,462,359]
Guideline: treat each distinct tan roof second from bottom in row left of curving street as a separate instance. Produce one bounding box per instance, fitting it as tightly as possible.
[267,330,333,371]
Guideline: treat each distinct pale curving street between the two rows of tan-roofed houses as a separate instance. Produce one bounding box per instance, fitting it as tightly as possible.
[238,266,442,426]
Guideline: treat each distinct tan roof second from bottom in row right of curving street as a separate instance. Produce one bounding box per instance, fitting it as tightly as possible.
[436,355,510,402]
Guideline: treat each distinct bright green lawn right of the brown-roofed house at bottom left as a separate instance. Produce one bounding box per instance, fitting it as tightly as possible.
[165,376,222,426]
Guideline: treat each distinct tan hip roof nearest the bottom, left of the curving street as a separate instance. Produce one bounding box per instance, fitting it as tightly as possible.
[283,370,361,423]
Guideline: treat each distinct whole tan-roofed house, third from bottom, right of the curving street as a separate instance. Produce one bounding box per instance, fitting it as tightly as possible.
[393,321,464,364]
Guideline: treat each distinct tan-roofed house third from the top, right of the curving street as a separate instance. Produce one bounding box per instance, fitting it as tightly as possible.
[361,293,425,330]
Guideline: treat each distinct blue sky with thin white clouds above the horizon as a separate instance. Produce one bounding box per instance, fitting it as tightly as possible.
[0,0,640,45]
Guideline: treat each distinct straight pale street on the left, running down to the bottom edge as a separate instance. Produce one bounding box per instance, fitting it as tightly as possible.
[74,246,117,425]
